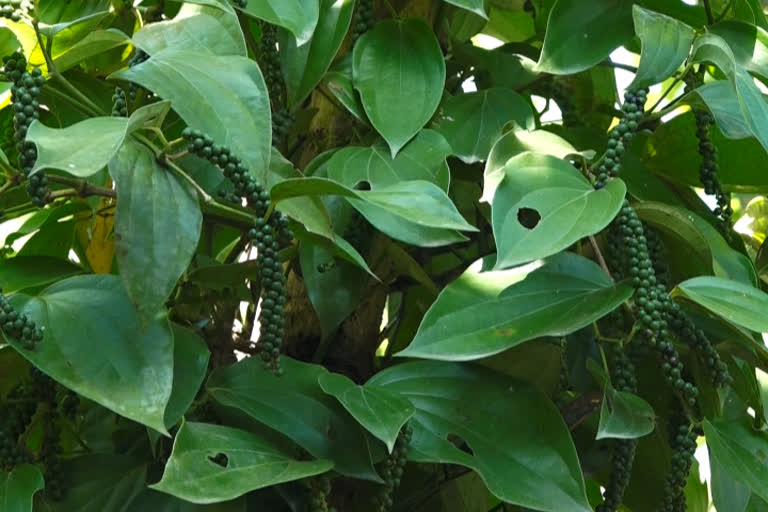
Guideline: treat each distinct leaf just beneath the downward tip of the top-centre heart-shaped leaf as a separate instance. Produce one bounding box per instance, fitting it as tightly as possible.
[327,130,451,192]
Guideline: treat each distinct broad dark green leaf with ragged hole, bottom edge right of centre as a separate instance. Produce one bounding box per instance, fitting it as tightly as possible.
[366,361,592,512]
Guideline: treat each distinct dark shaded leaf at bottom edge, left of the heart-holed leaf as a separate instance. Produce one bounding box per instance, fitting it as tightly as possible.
[35,453,147,512]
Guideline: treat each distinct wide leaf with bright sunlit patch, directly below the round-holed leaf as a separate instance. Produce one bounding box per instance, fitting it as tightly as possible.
[397,253,632,361]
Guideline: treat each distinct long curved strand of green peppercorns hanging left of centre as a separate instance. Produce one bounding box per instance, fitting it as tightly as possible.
[182,128,293,375]
